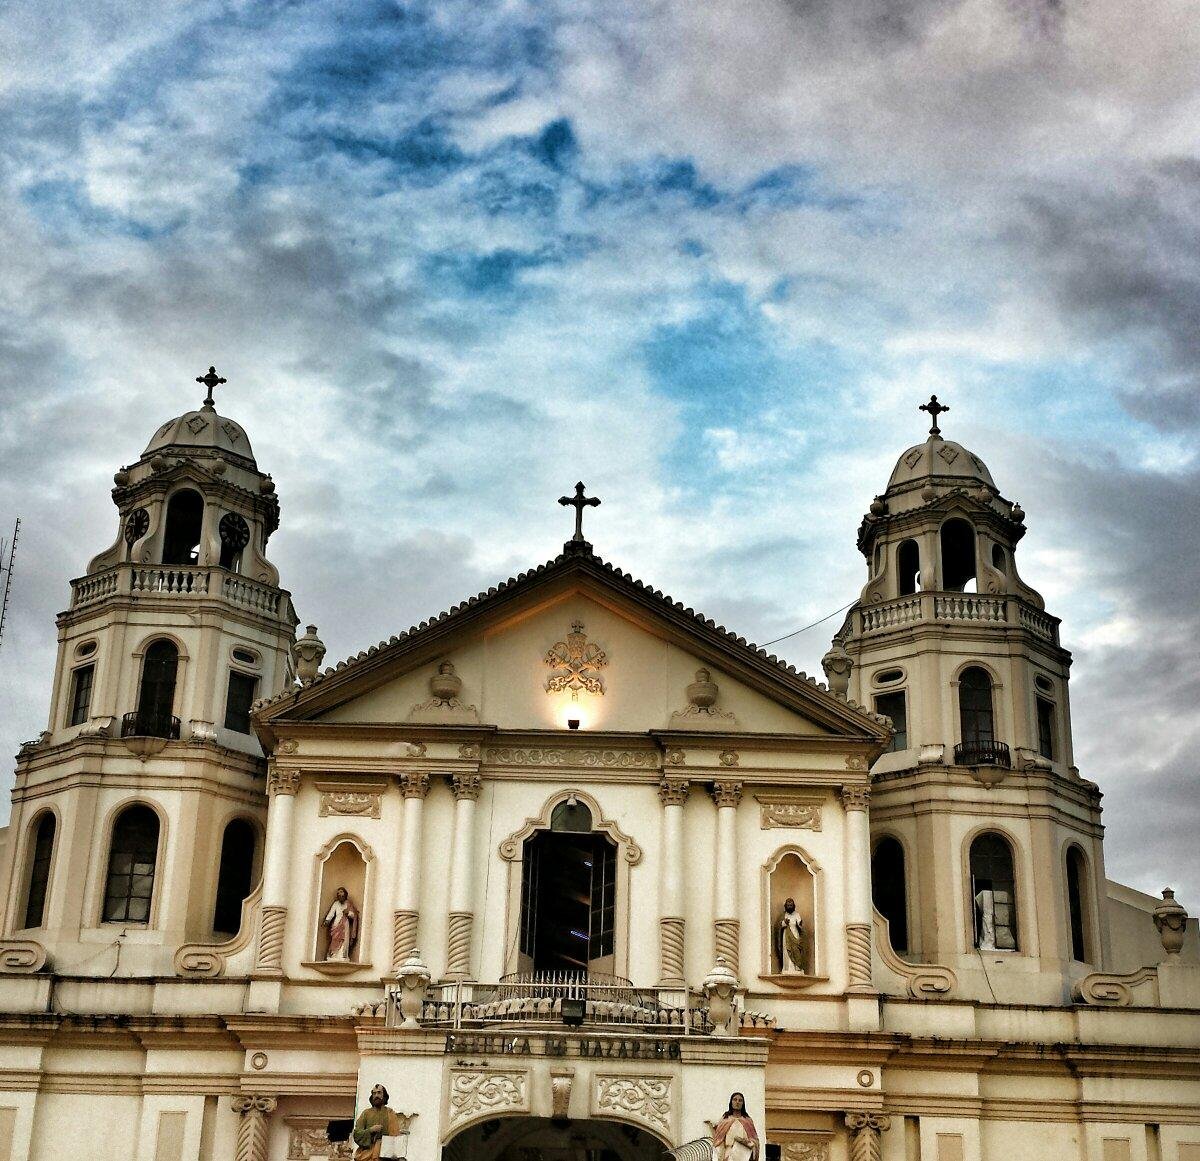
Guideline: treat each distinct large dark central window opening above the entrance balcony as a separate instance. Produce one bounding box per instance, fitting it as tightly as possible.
[521,825,617,973]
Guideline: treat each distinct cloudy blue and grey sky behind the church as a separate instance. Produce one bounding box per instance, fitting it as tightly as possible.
[0,0,1200,912]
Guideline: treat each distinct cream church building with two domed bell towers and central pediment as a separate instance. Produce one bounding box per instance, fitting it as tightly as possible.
[0,368,1200,1161]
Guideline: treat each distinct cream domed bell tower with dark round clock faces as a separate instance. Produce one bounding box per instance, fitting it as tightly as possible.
[4,367,296,975]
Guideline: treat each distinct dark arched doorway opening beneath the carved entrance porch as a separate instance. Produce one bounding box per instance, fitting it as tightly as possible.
[442,1117,667,1161]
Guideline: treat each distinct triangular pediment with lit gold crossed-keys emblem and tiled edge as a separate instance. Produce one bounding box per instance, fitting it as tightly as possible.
[259,554,887,740]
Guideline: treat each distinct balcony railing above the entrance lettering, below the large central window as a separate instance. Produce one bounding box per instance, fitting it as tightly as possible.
[388,971,713,1035]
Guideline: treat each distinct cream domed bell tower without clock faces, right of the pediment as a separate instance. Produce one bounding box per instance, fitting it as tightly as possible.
[823,396,1108,1001]
